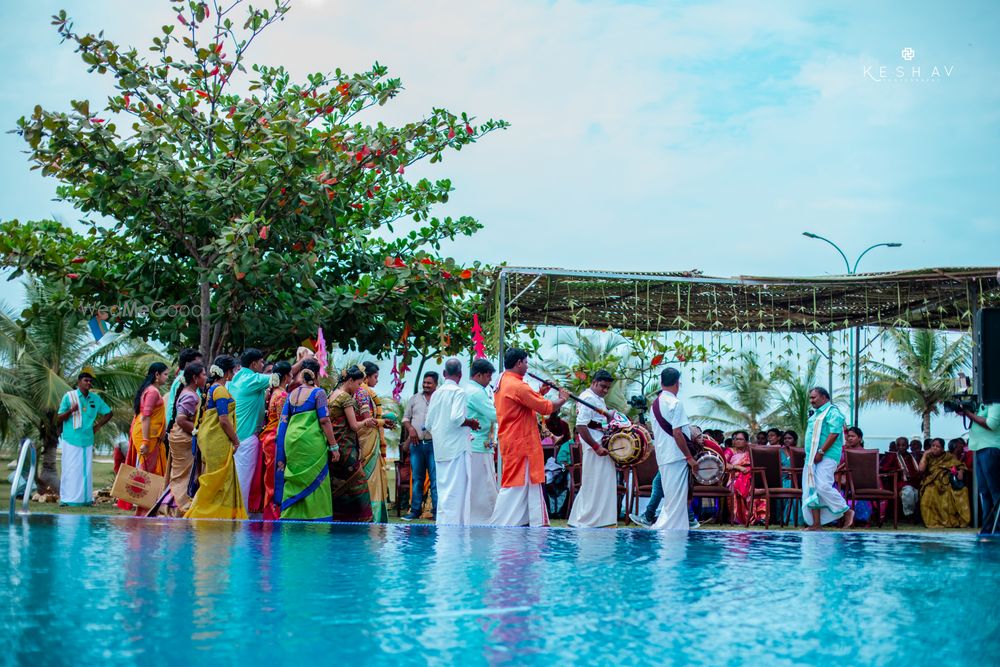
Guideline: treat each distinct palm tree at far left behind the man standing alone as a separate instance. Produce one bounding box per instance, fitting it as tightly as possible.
[0,280,163,490]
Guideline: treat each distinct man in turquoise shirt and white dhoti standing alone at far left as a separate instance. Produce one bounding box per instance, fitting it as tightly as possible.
[56,370,112,505]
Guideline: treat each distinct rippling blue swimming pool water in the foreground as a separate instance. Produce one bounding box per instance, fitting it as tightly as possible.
[0,515,1000,667]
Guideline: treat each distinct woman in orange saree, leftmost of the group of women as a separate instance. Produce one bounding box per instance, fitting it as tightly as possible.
[118,361,167,516]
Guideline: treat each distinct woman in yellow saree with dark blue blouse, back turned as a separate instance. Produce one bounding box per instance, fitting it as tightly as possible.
[184,354,247,519]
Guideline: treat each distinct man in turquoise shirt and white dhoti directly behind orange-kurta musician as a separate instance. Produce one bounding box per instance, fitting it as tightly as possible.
[465,359,500,525]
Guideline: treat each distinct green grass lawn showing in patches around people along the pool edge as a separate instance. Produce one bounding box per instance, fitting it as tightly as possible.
[0,451,976,533]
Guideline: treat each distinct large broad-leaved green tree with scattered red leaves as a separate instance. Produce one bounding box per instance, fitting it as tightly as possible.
[0,0,506,355]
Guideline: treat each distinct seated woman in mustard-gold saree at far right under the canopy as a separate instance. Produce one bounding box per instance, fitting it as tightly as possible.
[920,438,972,528]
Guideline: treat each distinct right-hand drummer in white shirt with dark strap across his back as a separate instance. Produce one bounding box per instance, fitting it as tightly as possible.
[652,368,697,530]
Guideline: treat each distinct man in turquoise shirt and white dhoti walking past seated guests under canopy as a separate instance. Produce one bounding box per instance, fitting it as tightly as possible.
[802,387,854,530]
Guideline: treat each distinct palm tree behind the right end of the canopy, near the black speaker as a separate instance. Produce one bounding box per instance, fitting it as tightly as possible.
[861,329,972,439]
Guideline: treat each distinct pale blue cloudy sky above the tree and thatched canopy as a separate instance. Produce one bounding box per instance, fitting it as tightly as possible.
[0,0,1000,448]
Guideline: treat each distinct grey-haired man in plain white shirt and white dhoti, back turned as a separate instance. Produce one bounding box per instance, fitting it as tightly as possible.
[427,359,479,526]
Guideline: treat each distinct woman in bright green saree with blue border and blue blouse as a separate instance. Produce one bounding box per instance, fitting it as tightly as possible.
[268,359,340,521]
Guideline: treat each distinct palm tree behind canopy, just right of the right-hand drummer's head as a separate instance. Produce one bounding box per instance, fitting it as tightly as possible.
[692,351,781,432]
